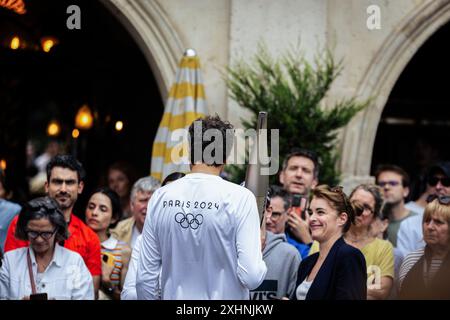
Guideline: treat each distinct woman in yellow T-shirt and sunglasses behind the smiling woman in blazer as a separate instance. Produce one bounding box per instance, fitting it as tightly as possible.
[311,184,394,300]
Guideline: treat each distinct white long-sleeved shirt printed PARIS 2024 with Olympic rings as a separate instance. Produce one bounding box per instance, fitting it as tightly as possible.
[136,173,267,300]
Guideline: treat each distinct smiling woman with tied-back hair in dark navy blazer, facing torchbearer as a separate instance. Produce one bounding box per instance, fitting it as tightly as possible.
[294,185,367,300]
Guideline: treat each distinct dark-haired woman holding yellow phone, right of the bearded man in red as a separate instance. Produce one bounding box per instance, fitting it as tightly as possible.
[86,188,131,300]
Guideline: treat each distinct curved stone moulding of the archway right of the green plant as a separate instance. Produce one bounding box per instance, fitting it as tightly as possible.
[340,0,450,188]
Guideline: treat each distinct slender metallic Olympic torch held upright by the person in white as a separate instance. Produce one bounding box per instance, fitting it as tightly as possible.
[245,112,269,223]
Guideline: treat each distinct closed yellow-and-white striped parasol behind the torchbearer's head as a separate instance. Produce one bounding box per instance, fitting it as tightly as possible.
[151,49,206,181]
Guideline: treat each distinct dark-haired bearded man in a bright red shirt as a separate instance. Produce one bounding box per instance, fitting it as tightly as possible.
[5,155,102,297]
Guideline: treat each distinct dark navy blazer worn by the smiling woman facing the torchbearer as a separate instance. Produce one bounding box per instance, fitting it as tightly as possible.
[292,237,367,300]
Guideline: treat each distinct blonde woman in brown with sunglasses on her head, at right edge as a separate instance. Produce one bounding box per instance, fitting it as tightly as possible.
[399,195,450,299]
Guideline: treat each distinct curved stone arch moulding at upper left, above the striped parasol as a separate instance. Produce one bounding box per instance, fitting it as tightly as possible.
[100,0,185,101]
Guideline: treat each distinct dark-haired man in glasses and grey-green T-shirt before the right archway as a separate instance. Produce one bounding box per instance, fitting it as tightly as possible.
[375,164,416,247]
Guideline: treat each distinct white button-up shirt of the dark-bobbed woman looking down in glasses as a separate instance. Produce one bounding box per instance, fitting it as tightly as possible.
[0,244,94,300]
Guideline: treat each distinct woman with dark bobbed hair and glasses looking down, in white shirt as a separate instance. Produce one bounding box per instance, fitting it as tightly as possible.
[0,197,94,300]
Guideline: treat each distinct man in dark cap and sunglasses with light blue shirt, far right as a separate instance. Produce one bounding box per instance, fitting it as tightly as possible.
[397,162,450,257]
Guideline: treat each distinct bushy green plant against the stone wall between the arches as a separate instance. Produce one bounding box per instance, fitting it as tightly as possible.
[226,45,369,185]
